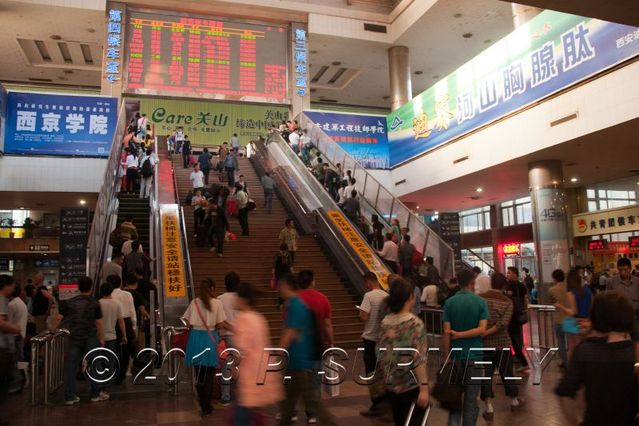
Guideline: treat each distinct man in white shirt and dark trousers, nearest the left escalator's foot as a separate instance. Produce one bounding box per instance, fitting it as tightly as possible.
[107,275,137,384]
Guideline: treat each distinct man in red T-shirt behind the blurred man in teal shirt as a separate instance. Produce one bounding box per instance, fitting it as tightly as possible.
[297,270,335,424]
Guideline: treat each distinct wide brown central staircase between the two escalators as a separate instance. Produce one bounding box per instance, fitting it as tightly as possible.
[173,157,363,347]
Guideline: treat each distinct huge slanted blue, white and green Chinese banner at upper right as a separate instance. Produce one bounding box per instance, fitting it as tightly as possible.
[386,10,639,166]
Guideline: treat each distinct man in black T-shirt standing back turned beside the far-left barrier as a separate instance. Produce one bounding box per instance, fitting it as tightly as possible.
[52,277,109,405]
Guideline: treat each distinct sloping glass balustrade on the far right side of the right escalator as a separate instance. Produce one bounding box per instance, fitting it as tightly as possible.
[298,113,455,281]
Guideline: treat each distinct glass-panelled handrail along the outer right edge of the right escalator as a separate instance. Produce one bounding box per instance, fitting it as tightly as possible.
[298,113,455,280]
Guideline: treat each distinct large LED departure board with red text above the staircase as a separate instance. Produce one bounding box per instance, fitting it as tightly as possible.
[126,12,288,103]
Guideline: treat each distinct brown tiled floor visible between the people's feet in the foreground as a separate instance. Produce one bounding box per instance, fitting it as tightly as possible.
[0,356,582,426]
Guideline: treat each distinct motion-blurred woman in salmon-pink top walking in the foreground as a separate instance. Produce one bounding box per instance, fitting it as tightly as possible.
[232,283,283,426]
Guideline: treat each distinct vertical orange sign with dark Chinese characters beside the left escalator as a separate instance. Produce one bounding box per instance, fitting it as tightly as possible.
[160,204,186,297]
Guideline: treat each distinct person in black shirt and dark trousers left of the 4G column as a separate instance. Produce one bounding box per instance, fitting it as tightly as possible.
[504,266,530,373]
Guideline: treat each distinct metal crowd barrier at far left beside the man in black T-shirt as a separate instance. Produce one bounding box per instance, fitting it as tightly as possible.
[31,328,69,405]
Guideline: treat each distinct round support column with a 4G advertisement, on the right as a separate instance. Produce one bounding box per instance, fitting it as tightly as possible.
[528,160,570,303]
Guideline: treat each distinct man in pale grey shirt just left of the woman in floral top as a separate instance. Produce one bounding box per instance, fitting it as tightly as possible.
[359,272,388,417]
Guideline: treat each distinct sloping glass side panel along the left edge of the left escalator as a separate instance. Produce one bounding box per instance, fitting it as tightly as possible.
[87,103,127,288]
